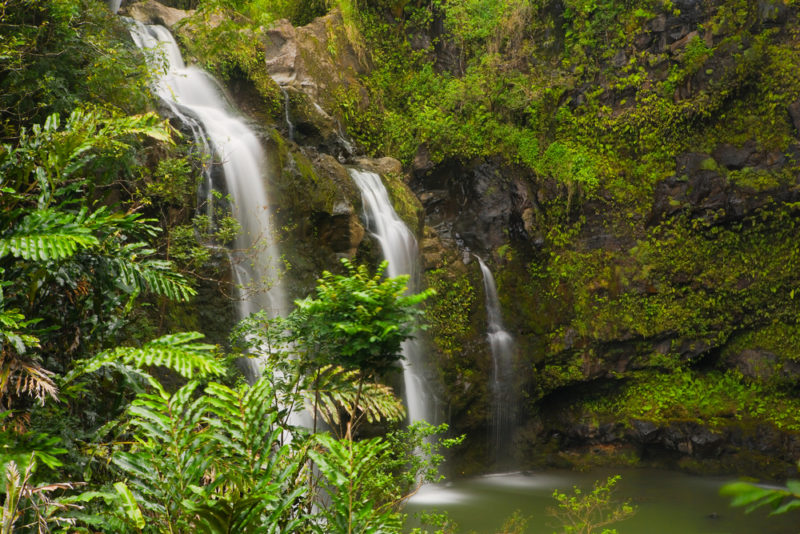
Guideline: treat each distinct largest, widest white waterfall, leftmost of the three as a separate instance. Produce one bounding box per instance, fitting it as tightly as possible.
[130,21,286,380]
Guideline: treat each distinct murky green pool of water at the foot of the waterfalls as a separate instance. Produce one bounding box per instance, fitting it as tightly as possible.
[406,469,800,534]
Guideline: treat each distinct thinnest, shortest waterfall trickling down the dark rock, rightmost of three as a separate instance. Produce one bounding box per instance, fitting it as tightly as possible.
[478,258,516,461]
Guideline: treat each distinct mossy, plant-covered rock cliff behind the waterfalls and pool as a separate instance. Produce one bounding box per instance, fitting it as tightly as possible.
[130,0,800,474]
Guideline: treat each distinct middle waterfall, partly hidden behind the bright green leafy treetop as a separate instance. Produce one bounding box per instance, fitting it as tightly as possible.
[350,169,433,423]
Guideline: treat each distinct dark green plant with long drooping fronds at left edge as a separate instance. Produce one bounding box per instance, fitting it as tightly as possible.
[0,109,194,412]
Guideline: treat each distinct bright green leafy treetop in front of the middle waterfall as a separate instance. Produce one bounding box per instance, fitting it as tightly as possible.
[292,260,433,373]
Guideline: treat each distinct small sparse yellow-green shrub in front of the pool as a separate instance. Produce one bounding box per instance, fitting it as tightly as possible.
[549,475,636,534]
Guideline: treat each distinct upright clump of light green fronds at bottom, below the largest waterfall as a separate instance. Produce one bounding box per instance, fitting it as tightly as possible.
[102,379,306,533]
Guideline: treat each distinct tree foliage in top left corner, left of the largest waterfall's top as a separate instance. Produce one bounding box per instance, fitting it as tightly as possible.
[0,0,150,131]
